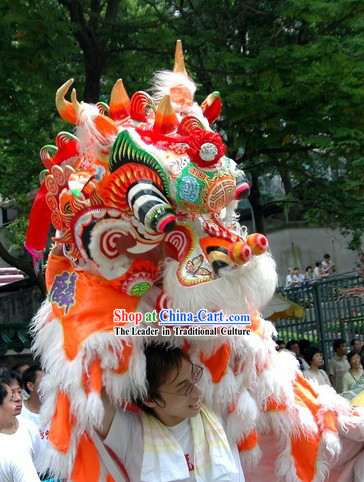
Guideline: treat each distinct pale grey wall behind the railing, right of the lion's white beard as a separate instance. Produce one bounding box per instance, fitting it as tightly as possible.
[267,228,364,284]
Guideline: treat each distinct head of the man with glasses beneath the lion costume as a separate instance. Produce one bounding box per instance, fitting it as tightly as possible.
[136,343,203,426]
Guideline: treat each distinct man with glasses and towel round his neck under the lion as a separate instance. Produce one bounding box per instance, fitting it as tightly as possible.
[99,344,244,482]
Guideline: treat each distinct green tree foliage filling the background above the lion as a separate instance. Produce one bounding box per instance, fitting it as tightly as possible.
[0,0,364,274]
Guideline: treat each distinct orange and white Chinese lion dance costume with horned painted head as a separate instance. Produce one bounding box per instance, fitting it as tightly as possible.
[26,41,362,482]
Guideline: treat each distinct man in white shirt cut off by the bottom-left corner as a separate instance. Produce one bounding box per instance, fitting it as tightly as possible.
[0,381,39,482]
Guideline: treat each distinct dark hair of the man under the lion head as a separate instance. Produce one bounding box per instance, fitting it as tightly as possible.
[135,343,189,415]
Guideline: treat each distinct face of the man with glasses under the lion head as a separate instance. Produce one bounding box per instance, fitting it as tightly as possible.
[144,358,203,426]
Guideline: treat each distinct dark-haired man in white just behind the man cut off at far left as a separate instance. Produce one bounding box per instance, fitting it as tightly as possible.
[0,370,40,465]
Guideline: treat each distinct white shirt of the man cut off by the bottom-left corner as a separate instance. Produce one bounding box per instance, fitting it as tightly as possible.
[0,434,39,482]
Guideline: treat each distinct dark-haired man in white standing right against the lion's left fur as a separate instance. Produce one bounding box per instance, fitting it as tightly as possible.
[21,364,49,480]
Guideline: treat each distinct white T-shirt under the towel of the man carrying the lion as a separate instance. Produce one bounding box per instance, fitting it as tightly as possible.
[104,409,245,482]
